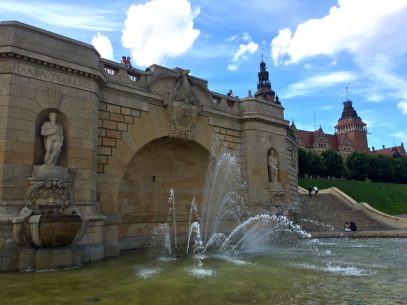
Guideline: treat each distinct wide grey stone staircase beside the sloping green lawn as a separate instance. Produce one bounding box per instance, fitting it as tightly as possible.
[300,189,400,233]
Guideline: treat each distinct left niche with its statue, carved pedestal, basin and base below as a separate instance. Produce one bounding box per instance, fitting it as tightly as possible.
[13,109,83,270]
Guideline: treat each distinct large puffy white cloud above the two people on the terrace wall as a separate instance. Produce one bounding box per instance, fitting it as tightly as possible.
[122,0,200,66]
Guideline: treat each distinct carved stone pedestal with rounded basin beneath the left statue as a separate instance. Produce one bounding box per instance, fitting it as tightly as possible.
[13,165,82,248]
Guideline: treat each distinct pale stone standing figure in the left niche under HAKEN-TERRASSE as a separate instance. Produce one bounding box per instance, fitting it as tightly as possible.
[41,112,64,165]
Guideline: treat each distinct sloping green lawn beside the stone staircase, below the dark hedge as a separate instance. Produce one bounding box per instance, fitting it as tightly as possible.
[298,178,407,215]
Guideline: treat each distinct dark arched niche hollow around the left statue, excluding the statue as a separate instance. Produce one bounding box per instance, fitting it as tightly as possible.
[34,108,69,167]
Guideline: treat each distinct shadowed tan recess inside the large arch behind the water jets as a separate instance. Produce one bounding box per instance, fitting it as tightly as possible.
[118,137,209,238]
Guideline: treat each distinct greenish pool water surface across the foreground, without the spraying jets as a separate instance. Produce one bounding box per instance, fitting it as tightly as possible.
[0,239,407,305]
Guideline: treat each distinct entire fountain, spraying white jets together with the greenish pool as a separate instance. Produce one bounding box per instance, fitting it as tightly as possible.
[0,138,407,305]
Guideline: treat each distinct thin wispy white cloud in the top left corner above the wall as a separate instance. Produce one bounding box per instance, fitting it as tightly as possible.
[0,0,121,31]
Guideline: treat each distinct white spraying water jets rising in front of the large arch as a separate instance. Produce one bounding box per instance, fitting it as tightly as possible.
[149,140,310,255]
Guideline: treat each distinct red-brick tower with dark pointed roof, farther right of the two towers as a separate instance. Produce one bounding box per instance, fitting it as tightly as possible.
[335,100,369,152]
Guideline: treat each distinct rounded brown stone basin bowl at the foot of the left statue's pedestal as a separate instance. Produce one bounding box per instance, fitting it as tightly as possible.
[23,215,82,248]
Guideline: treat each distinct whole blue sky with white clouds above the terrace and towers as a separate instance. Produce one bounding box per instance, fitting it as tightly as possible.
[0,0,407,148]
